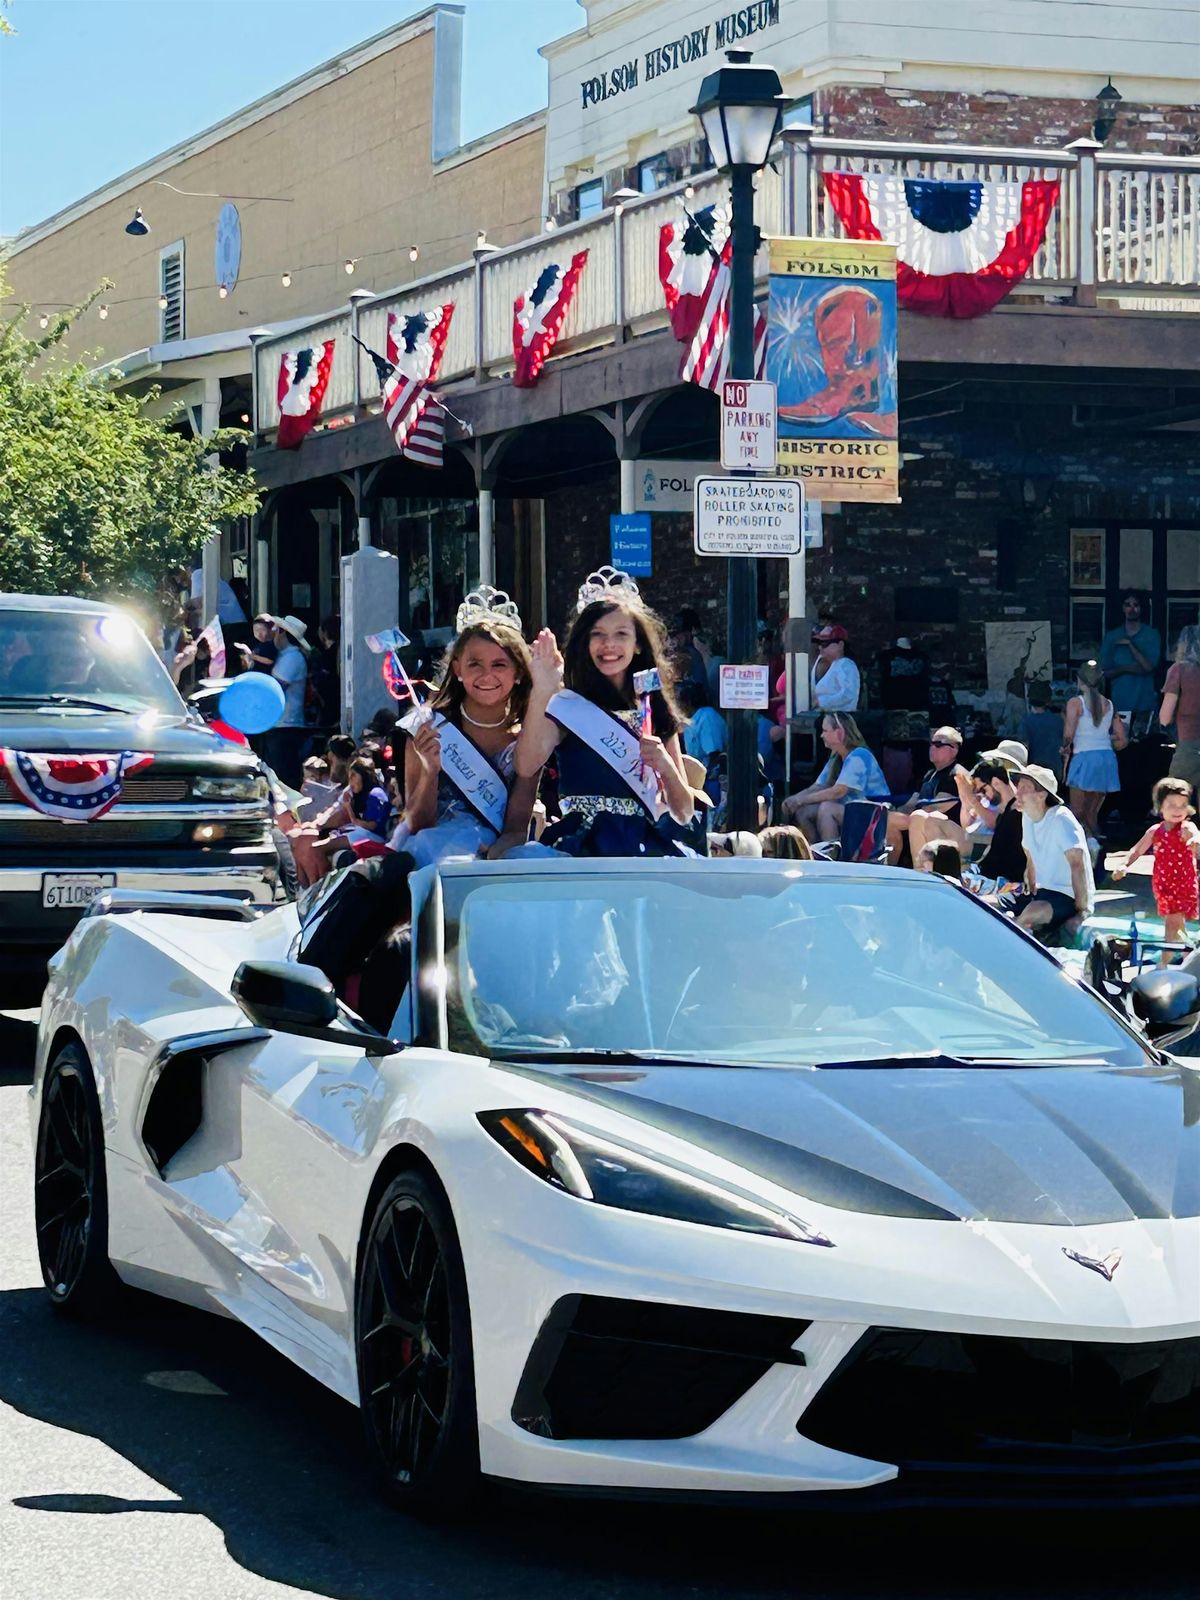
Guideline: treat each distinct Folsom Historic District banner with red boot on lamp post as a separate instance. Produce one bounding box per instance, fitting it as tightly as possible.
[766,238,899,504]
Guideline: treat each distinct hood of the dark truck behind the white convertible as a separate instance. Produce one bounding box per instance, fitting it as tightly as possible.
[0,706,253,770]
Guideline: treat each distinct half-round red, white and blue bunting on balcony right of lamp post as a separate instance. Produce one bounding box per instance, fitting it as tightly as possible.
[821,173,1059,317]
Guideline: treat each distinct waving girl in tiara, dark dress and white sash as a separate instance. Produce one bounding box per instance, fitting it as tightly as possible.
[517,566,694,856]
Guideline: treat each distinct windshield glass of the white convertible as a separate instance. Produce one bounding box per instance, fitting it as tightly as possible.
[446,864,1147,1067]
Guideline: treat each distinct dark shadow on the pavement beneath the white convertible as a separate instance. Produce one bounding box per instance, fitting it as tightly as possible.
[0,1290,1194,1600]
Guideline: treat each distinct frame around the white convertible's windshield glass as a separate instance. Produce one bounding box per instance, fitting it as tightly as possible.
[438,861,1163,1070]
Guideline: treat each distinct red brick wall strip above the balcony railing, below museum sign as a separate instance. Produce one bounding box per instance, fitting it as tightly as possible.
[813,85,1200,155]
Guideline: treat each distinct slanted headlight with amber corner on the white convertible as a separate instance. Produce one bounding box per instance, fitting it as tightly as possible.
[478,1110,834,1246]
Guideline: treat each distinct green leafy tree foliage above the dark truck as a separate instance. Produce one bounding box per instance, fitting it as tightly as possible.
[0,264,258,598]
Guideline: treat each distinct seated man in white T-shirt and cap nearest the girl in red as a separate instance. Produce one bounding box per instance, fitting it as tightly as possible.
[1011,766,1096,933]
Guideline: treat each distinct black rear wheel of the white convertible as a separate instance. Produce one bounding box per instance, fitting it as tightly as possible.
[34,1045,120,1314]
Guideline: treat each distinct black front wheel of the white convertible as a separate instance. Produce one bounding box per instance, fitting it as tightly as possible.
[355,1171,478,1517]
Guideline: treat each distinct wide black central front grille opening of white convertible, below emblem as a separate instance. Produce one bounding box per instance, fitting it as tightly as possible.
[797,1328,1200,1494]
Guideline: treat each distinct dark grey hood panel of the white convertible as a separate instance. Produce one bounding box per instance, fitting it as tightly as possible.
[496,1062,1200,1226]
